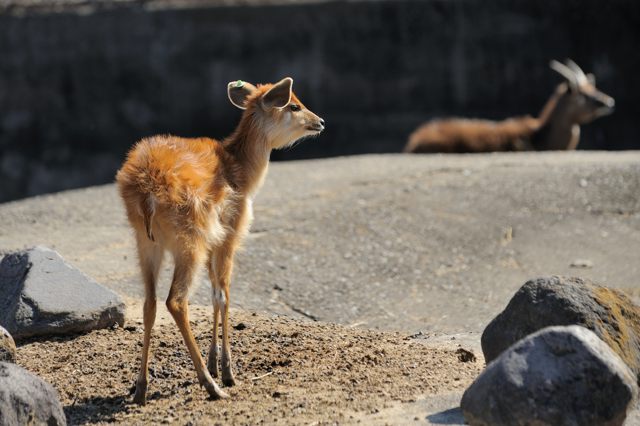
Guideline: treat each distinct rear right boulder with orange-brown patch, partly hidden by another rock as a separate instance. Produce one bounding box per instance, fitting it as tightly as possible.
[481,276,640,377]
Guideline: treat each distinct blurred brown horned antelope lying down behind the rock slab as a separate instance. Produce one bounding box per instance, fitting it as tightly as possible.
[404,59,615,153]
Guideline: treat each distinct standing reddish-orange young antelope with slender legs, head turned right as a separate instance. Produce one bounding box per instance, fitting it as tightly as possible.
[116,77,324,404]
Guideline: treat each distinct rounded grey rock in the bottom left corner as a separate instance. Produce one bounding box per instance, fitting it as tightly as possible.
[0,362,67,426]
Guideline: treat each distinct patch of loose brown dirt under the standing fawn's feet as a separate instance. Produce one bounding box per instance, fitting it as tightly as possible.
[18,303,484,424]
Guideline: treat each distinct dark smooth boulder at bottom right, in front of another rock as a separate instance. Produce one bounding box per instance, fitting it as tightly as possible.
[461,325,638,426]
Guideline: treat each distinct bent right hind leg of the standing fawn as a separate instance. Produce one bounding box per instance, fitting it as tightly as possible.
[167,249,228,399]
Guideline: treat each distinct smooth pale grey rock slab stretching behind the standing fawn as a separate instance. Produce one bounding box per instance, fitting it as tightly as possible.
[0,151,640,334]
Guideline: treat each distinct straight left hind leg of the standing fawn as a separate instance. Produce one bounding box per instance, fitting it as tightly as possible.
[133,236,164,405]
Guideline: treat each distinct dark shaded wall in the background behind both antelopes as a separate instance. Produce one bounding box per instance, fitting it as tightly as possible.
[0,0,640,201]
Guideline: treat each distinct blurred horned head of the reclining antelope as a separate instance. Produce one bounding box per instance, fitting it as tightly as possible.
[550,59,615,124]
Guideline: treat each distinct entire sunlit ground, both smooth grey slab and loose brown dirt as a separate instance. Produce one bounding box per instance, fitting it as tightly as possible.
[0,153,640,424]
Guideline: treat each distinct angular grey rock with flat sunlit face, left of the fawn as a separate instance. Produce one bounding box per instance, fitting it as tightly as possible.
[0,247,124,339]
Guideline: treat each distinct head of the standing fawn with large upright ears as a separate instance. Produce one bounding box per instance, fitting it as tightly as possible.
[227,77,324,149]
